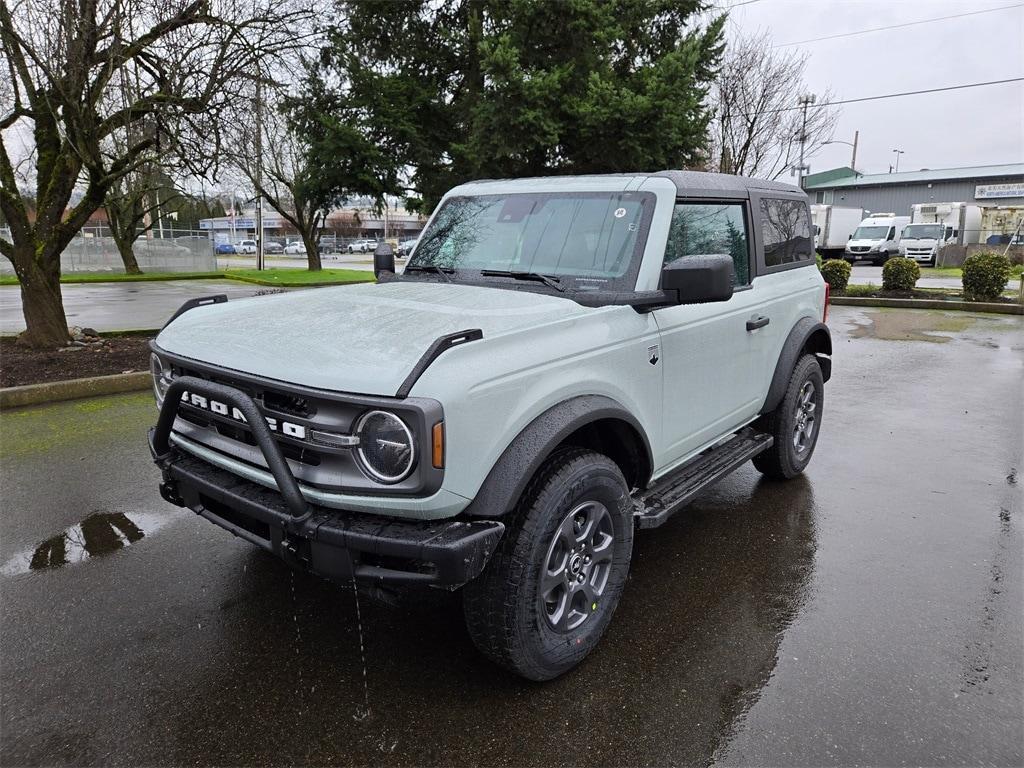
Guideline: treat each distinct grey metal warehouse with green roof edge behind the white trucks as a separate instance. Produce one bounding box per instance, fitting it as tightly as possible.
[804,163,1024,216]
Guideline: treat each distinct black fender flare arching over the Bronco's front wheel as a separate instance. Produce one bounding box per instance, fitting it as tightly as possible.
[464,394,653,517]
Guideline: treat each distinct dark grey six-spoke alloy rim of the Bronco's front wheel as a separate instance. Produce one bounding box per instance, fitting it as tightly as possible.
[538,501,614,633]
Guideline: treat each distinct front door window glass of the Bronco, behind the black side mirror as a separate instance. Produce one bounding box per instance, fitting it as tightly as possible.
[665,203,751,286]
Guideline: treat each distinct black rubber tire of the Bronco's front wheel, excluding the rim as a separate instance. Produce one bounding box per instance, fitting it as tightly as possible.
[463,449,633,680]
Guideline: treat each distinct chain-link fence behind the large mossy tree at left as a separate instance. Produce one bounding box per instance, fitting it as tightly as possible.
[0,225,217,274]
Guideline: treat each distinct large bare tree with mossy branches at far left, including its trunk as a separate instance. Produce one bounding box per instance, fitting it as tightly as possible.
[0,0,305,347]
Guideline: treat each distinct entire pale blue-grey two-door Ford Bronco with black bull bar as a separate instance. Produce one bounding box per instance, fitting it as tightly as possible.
[150,171,831,680]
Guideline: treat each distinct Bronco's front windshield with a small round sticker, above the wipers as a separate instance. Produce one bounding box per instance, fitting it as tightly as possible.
[406,193,654,291]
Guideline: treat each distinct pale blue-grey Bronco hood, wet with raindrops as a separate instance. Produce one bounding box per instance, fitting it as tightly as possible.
[157,282,594,395]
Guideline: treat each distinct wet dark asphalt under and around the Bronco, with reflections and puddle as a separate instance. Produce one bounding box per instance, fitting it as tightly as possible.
[0,307,1024,766]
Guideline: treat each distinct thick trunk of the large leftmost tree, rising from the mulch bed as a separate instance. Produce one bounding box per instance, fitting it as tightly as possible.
[12,243,71,349]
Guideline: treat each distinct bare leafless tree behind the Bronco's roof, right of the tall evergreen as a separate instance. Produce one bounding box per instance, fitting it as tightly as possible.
[709,35,839,179]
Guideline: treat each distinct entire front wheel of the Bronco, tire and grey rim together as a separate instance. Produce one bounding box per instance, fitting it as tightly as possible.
[463,449,633,680]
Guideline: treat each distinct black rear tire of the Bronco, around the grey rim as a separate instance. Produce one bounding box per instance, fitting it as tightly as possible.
[754,354,824,480]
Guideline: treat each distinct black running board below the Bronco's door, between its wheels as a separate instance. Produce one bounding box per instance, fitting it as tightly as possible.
[633,428,774,528]
